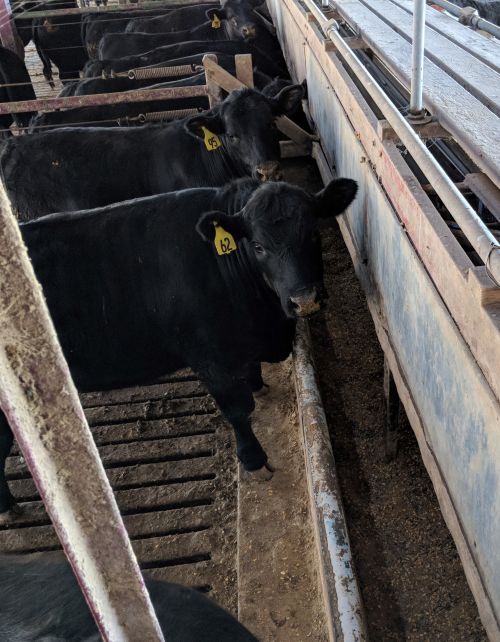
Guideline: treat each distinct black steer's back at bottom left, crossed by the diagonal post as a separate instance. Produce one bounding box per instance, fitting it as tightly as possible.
[0,553,257,642]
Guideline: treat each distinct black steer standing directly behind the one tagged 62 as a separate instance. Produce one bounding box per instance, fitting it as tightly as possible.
[0,85,303,220]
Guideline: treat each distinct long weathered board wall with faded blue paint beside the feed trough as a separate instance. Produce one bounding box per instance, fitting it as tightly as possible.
[270,0,500,639]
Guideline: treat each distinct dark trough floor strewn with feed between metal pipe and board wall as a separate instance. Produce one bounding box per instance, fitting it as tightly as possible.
[310,218,487,642]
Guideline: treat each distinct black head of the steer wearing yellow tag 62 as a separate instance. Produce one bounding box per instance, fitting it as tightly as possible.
[197,178,358,318]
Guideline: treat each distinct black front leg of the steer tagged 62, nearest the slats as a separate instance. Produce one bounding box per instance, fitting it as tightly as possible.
[198,366,267,471]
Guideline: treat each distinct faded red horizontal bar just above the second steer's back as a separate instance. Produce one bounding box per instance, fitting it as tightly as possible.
[0,85,207,114]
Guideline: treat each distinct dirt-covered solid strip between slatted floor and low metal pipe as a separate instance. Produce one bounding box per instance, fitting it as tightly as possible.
[238,359,328,642]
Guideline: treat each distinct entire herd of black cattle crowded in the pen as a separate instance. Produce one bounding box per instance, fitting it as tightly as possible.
[0,0,357,642]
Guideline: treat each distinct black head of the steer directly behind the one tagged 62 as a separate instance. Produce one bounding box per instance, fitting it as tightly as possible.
[184,85,304,181]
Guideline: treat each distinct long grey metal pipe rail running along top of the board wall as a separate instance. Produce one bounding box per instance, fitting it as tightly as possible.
[302,0,500,286]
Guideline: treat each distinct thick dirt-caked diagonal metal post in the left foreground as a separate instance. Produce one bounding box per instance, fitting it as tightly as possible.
[0,185,163,642]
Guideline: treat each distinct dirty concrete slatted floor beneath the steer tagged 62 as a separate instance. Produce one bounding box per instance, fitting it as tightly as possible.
[0,372,237,611]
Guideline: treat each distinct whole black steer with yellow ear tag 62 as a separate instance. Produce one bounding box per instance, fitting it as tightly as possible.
[0,179,357,511]
